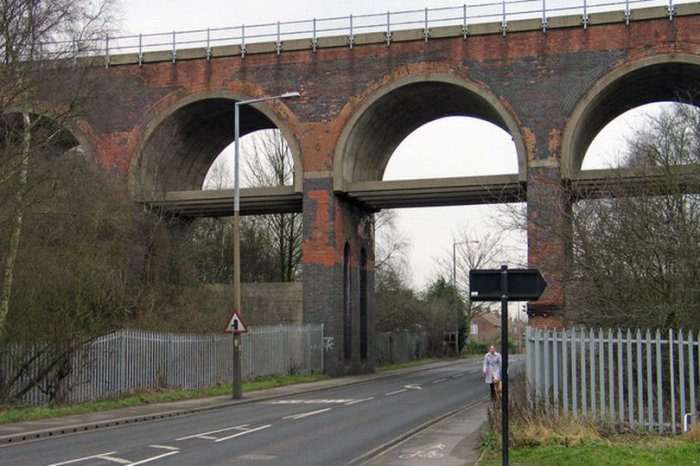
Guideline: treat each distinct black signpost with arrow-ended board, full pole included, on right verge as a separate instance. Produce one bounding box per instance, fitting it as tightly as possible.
[469,265,547,466]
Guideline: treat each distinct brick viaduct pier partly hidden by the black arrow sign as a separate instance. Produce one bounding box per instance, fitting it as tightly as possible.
[527,167,572,328]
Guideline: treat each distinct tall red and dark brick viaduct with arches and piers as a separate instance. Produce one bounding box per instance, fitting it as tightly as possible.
[24,3,700,373]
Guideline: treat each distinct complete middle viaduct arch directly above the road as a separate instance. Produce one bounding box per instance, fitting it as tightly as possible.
[333,73,527,189]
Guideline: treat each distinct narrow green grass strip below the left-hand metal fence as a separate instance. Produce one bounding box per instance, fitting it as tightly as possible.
[0,374,327,424]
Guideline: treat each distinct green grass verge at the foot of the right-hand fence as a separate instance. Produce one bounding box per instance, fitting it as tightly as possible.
[479,437,700,466]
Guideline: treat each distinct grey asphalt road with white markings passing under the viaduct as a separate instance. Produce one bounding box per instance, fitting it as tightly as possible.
[0,360,504,466]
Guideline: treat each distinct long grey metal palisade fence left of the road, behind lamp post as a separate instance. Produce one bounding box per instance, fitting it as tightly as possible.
[0,324,323,405]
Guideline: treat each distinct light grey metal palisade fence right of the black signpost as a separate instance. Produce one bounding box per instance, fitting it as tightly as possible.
[525,327,700,433]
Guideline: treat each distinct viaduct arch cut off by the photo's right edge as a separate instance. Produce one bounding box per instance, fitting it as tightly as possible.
[561,54,700,179]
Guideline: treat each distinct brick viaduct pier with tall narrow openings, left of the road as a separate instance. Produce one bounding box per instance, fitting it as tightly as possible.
[302,178,375,375]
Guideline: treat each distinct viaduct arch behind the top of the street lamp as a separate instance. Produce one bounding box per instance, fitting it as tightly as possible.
[129,90,303,197]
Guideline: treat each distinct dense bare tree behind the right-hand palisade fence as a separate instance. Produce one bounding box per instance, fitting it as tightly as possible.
[568,105,700,330]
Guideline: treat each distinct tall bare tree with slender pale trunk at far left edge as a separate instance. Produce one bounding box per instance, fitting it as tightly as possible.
[0,0,116,334]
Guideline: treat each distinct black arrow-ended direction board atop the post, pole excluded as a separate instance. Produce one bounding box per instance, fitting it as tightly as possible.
[469,269,547,301]
